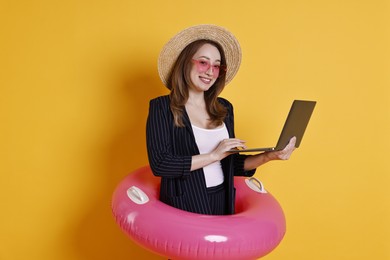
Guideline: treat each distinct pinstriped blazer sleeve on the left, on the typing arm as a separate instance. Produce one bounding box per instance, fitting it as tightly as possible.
[146,97,192,178]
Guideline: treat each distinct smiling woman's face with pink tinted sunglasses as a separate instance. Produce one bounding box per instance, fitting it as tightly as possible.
[190,43,222,91]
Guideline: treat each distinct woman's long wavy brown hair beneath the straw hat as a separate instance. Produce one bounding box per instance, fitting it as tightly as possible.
[167,40,227,127]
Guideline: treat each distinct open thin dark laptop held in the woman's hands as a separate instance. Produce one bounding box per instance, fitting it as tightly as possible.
[229,100,317,153]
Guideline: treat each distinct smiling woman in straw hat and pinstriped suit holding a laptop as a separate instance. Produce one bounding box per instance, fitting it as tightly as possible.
[146,25,295,215]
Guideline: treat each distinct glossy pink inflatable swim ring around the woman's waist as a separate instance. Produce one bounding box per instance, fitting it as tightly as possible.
[112,166,286,260]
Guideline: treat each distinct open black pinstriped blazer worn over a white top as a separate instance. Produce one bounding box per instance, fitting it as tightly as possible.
[146,96,255,214]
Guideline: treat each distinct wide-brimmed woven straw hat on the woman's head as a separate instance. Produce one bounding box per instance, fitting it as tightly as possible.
[158,24,241,86]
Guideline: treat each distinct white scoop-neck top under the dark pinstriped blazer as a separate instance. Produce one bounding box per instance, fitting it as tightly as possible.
[192,124,229,187]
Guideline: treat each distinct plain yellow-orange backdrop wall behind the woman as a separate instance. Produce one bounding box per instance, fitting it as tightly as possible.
[0,0,390,260]
